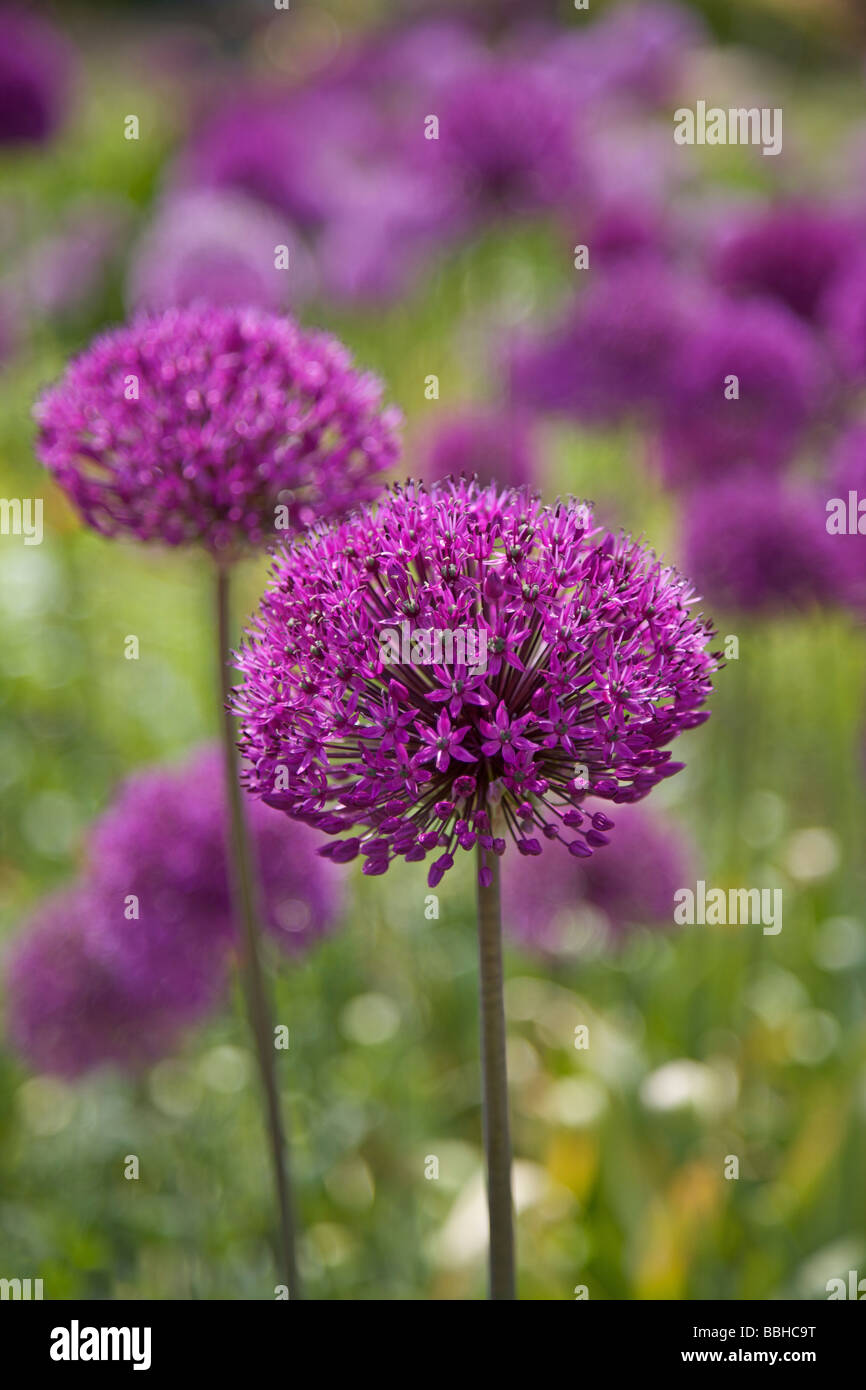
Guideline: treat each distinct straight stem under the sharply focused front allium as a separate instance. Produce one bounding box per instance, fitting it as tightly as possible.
[478,847,517,1298]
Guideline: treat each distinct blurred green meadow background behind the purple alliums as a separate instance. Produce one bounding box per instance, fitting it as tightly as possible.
[0,0,866,1300]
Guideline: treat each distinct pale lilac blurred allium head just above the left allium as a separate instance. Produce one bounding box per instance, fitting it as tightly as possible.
[126,189,314,311]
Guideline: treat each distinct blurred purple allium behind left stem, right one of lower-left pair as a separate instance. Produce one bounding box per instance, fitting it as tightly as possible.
[88,748,339,1015]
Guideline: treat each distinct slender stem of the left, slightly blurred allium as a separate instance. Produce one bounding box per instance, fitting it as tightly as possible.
[215,566,302,1298]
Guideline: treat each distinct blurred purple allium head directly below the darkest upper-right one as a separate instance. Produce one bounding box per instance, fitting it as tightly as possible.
[662,300,824,482]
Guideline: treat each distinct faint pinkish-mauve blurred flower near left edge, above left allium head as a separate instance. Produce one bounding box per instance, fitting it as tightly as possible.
[22,199,129,318]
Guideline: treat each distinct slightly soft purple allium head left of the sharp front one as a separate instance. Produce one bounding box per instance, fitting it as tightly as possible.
[35,306,399,552]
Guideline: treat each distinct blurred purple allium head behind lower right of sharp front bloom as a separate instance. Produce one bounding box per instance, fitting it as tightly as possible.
[502,802,694,954]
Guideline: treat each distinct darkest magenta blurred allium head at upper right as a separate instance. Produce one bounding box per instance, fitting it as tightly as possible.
[710,203,859,320]
